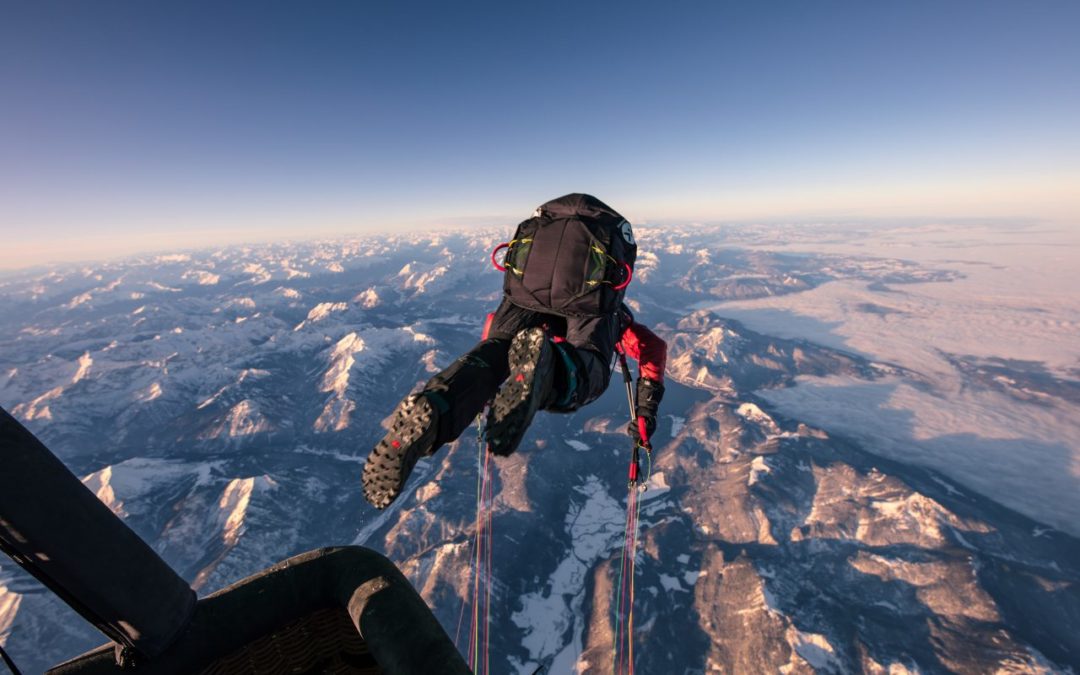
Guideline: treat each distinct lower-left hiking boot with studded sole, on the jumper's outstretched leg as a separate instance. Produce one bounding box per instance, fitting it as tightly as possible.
[364,394,438,509]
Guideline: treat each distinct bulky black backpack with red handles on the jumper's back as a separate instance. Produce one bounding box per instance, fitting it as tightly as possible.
[491,193,637,318]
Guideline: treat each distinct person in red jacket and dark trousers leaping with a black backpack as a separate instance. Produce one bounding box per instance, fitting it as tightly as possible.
[363,193,667,509]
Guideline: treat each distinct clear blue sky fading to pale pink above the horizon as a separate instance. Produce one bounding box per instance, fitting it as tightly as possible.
[0,0,1080,269]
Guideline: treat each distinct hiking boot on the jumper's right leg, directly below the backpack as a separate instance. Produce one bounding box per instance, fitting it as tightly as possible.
[487,328,555,456]
